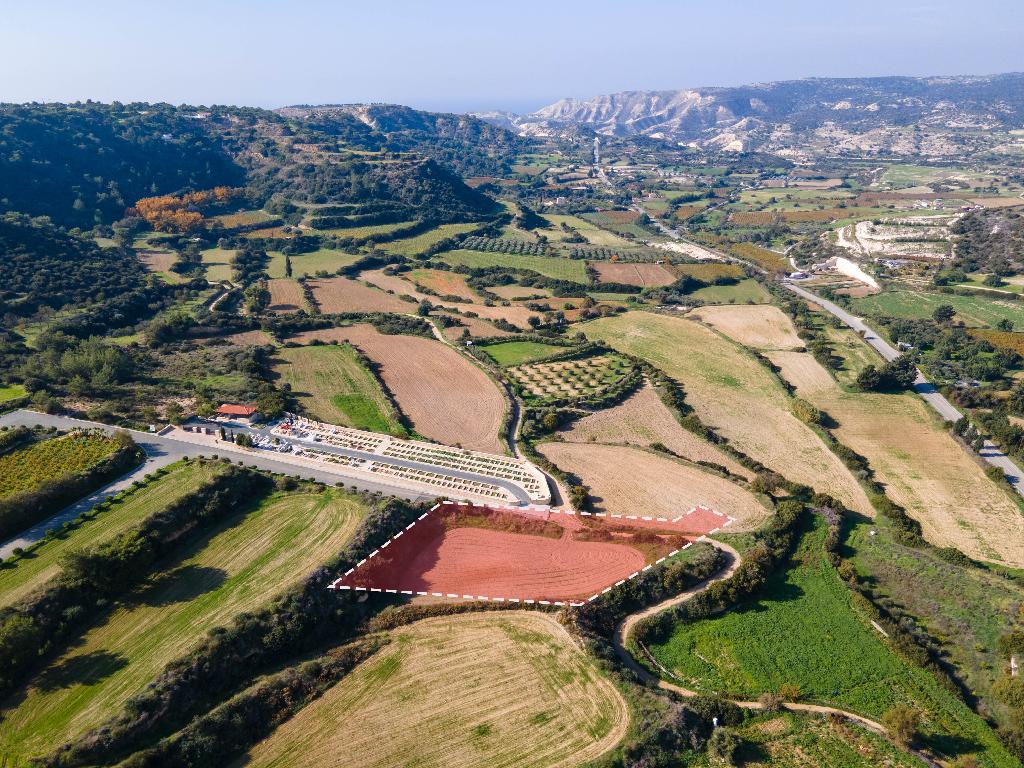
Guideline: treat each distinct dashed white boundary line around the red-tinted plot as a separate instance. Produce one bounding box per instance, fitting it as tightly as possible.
[328,501,735,607]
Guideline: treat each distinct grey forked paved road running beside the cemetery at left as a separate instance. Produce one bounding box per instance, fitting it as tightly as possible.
[0,411,447,558]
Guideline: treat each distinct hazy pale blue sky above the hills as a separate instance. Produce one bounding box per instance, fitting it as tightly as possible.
[0,0,1024,111]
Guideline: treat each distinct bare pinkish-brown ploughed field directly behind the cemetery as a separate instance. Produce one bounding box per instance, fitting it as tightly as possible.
[296,325,505,454]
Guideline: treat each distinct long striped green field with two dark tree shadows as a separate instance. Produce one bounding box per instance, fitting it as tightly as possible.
[0,490,366,758]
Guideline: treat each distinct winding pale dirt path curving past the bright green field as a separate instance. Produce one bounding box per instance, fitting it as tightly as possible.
[613,538,886,735]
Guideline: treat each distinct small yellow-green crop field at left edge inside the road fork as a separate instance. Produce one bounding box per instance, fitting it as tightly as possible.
[0,435,118,498]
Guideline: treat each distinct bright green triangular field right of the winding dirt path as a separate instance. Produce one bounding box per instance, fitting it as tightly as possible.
[650,521,1016,766]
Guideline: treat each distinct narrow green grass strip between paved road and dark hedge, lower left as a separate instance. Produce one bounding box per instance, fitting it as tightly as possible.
[0,462,220,607]
